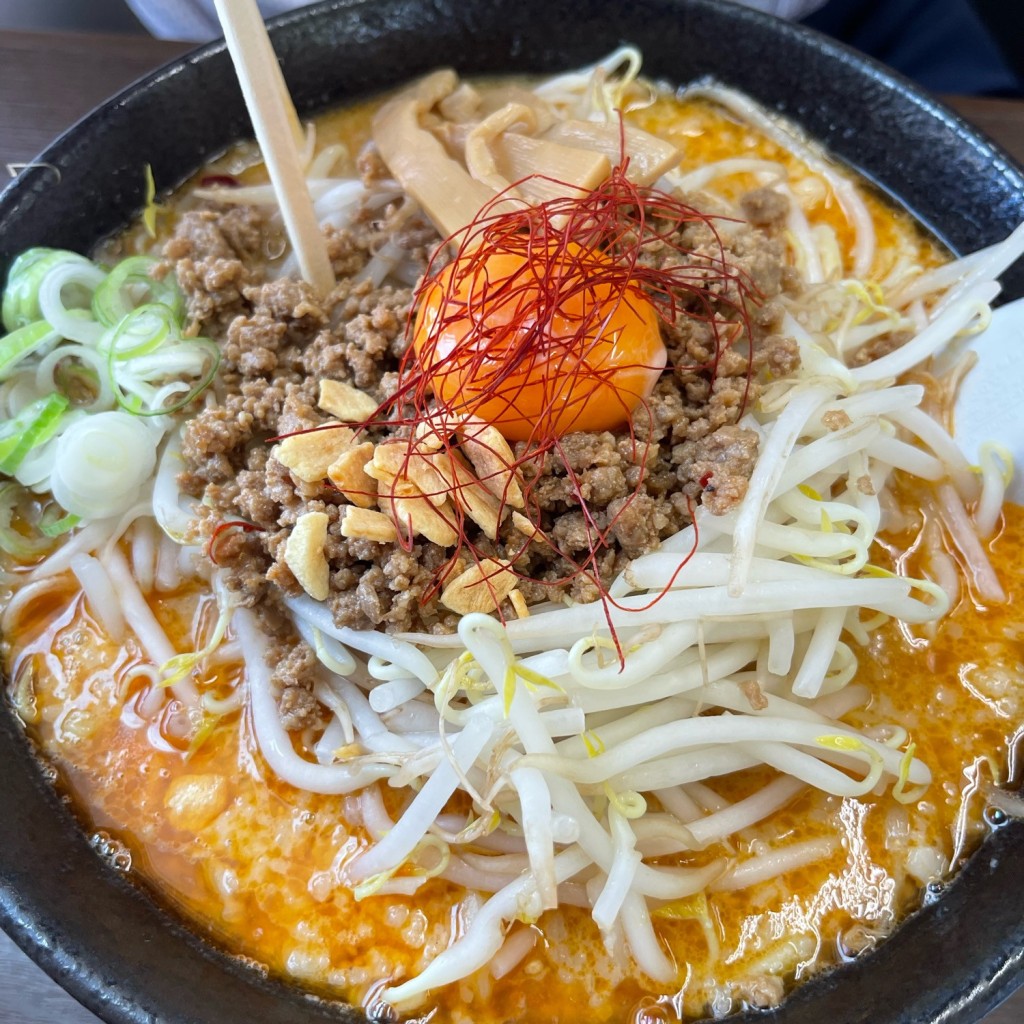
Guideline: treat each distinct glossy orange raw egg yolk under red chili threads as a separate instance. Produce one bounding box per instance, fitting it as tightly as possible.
[413,243,667,441]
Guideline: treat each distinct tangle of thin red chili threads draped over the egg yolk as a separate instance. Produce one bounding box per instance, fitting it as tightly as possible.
[268,163,761,654]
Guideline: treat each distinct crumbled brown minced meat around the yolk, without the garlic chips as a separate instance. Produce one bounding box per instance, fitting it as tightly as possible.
[172,179,799,643]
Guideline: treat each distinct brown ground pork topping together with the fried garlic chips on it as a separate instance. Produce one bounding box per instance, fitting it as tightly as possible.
[178,178,799,647]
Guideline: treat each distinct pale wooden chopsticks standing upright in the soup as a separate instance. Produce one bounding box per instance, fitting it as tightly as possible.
[215,0,335,295]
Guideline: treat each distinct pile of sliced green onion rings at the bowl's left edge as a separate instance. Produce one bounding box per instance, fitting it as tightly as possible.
[0,236,220,520]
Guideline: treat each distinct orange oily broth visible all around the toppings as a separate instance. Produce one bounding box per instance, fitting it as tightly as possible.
[8,86,1024,1021]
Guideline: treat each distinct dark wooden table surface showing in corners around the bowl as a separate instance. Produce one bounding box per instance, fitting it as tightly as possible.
[0,22,1024,1024]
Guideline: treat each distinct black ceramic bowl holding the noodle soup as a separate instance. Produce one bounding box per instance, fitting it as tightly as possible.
[0,0,1024,1024]
